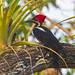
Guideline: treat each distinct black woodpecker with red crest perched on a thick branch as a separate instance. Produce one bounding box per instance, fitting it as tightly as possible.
[26,14,64,69]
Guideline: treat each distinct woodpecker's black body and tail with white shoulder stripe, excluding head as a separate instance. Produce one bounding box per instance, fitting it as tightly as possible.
[33,25,63,68]
